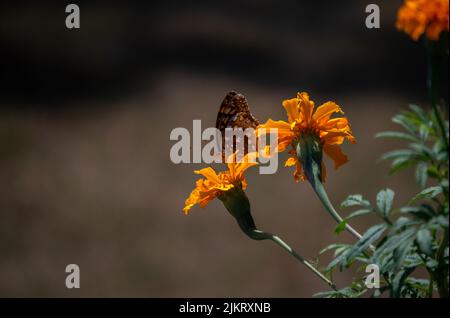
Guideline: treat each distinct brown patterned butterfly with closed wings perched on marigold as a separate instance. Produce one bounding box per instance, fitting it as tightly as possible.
[216,91,259,158]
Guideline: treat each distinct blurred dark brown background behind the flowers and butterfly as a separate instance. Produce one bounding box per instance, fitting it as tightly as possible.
[0,0,448,297]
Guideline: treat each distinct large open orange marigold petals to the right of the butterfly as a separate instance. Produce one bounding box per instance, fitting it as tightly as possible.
[258,92,356,181]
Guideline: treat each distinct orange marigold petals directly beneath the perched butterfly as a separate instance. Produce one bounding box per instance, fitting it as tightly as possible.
[183,153,258,214]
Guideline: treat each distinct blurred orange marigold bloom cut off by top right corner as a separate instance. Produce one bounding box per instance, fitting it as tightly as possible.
[396,0,449,41]
